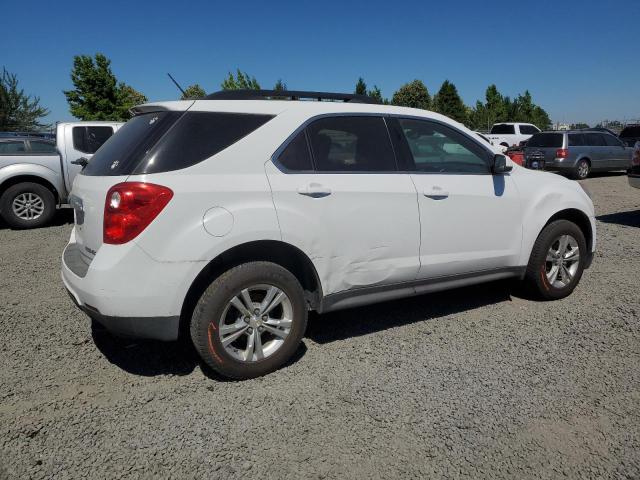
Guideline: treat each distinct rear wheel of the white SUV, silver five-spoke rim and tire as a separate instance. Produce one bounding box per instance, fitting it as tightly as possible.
[191,262,307,379]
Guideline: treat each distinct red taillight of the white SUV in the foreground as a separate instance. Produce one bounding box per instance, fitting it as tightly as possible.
[102,182,173,245]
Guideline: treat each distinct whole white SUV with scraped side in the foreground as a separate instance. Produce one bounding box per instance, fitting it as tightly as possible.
[62,91,596,378]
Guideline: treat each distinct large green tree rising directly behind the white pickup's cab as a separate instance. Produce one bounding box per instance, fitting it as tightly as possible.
[64,53,147,121]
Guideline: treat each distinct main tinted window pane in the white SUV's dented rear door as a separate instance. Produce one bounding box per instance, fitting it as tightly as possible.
[307,116,396,172]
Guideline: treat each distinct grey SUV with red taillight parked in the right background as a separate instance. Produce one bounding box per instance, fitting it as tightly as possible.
[524,130,633,180]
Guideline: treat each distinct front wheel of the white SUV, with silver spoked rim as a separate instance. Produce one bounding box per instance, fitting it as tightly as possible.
[525,220,587,300]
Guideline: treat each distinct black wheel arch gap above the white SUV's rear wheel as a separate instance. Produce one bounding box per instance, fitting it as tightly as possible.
[180,240,322,338]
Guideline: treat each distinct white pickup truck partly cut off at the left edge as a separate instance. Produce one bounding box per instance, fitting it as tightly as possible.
[0,122,122,228]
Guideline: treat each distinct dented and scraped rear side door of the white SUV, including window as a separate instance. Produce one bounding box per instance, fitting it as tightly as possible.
[266,115,420,295]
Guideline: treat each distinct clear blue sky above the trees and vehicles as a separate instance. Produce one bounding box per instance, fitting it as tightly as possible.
[0,0,640,123]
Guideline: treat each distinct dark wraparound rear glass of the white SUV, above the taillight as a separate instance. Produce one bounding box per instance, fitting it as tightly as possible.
[82,111,273,176]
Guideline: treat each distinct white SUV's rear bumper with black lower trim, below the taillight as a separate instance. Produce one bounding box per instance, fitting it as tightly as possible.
[61,229,200,341]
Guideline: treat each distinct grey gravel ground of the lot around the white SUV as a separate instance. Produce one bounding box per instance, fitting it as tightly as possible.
[0,175,640,479]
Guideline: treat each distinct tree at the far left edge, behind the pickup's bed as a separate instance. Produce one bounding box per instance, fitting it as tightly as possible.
[0,67,49,131]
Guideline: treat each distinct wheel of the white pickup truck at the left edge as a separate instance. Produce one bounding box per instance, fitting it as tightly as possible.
[0,182,56,228]
